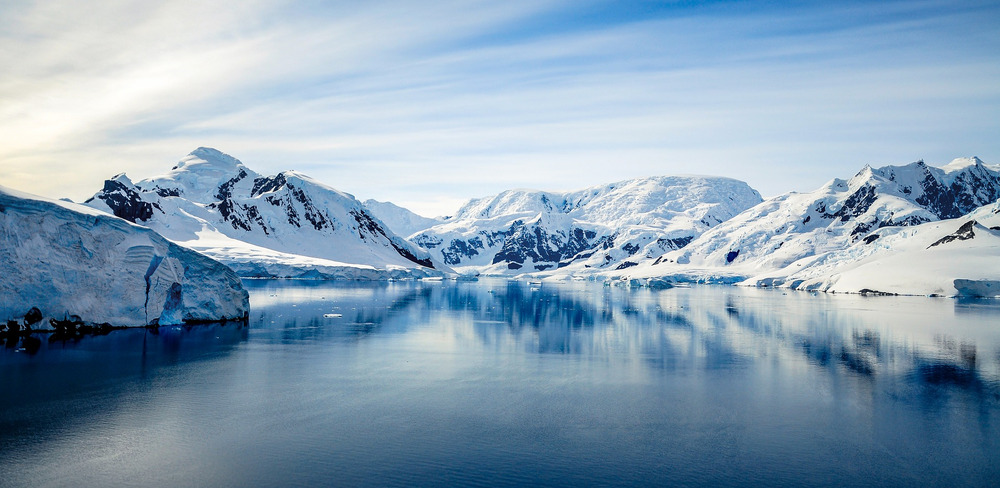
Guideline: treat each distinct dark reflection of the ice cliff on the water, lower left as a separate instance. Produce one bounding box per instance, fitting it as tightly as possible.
[0,323,248,444]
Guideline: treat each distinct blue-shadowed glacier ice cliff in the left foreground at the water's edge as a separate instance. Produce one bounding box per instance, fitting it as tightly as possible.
[0,187,249,328]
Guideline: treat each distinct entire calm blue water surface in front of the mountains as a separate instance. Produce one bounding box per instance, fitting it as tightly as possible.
[0,281,1000,487]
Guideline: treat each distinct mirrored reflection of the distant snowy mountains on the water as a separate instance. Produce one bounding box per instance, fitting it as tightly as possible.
[238,280,1000,402]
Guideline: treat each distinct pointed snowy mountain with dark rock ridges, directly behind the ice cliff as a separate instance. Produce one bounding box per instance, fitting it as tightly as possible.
[85,147,446,279]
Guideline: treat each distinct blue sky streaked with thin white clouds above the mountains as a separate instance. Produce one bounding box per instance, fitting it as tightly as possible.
[0,0,1000,216]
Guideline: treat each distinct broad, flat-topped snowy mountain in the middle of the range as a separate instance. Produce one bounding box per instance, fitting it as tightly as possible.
[410,176,761,273]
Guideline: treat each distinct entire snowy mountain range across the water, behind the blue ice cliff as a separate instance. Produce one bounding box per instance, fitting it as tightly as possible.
[1,143,984,295]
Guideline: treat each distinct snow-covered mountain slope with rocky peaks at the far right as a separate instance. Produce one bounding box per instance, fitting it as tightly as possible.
[619,158,1000,295]
